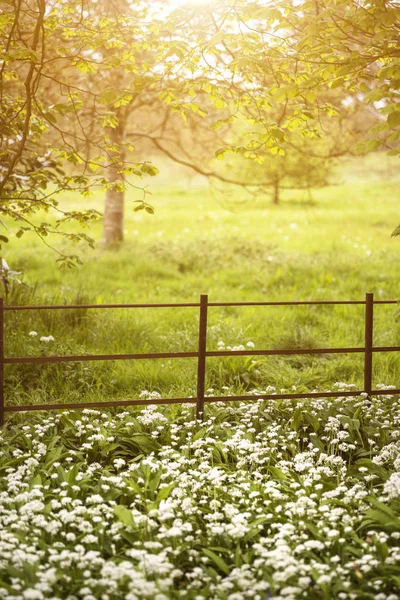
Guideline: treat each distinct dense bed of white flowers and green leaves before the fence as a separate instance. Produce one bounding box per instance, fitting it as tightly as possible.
[0,392,400,600]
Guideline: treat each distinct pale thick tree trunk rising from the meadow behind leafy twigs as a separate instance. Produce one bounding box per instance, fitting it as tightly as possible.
[103,121,125,248]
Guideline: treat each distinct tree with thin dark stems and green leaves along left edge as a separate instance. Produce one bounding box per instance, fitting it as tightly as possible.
[0,0,164,253]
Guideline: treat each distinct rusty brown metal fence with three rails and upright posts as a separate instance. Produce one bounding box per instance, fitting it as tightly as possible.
[0,293,400,425]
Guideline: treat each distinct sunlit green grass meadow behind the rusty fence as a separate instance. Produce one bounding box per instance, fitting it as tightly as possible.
[6,155,400,410]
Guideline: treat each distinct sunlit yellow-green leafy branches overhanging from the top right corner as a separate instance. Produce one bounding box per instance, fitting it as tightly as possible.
[217,0,400,154]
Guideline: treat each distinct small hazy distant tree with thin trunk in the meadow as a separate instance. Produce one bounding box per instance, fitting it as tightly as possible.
[214,89,377,204]
